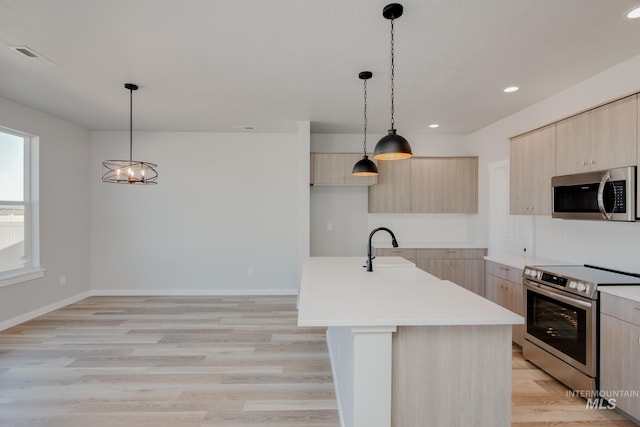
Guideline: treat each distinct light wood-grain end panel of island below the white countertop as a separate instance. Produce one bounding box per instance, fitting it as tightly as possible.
[391,325,511,427]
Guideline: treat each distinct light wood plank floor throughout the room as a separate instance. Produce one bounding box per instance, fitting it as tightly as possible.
[0,296,634,427]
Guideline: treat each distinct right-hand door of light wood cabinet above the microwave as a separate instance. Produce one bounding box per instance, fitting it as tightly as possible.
[588,95,638,170]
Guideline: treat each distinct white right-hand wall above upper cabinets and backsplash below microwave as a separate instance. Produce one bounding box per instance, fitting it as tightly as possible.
[468,56,640,272]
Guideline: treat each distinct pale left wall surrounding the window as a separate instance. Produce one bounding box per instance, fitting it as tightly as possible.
[0,98,92,326]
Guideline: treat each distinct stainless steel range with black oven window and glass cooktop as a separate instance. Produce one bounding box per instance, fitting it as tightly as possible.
[522,265,640,391]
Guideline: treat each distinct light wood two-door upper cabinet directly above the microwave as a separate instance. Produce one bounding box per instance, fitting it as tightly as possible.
[555,95,638,175]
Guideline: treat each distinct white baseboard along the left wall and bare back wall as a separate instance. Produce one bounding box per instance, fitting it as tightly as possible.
[0,289,298,331]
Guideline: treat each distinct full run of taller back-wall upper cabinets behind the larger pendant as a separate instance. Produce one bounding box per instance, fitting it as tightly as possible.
[369,157,478,213]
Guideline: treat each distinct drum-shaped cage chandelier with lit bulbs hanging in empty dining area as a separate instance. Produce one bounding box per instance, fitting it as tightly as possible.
[102,83,158,184]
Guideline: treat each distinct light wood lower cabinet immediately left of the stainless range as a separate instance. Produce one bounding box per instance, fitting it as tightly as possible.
[485,261,524,347]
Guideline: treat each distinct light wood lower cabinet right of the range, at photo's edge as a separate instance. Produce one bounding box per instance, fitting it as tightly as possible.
[600,294,640,420]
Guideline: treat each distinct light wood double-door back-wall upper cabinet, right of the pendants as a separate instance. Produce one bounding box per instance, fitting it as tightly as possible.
[411,157,478,213]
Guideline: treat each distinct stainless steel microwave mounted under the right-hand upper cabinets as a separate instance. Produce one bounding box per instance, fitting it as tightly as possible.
[551,166,636,221]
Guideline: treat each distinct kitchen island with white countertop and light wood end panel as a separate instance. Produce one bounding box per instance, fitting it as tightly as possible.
[298,257,524,427]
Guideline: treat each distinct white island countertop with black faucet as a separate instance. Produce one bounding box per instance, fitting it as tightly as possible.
[298,257,524,326]
